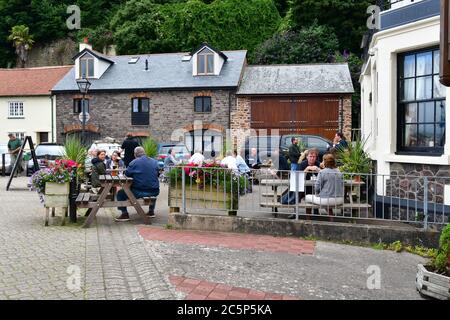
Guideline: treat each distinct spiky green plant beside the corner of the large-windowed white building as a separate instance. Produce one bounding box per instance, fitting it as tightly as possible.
[337,139,372,181]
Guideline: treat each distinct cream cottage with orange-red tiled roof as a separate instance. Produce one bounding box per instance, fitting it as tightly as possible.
[0,66,72,143]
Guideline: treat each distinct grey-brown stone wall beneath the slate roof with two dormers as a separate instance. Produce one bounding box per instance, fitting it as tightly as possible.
[56,90,235,142]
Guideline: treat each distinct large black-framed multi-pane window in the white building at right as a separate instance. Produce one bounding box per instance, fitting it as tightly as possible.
[397,49,445,154]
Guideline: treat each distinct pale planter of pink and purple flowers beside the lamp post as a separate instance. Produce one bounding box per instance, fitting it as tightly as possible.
[31,159,78,208]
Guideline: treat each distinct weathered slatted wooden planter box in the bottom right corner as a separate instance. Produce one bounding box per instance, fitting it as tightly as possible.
[416,264,450,300]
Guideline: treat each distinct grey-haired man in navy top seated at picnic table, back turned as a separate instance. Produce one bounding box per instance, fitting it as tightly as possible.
[116,147,159,221]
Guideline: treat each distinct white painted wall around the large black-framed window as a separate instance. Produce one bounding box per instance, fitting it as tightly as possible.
[360,16,450,199]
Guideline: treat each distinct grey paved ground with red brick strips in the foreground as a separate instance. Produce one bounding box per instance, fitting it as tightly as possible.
[0,177,424,299]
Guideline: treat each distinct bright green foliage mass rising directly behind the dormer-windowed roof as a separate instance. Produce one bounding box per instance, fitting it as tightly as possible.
[111,0,281,53]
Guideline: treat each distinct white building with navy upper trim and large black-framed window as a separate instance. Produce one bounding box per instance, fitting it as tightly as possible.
[360,0,450,204]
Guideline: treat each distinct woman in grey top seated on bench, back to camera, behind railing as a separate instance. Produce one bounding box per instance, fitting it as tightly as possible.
[305,154,344,215]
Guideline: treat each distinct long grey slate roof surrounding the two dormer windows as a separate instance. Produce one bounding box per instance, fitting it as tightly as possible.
[52,50,247,93]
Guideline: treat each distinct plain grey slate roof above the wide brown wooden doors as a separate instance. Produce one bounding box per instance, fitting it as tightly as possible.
[237,63,354,95]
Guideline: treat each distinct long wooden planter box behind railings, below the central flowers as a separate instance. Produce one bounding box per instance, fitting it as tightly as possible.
[169,184,239,215]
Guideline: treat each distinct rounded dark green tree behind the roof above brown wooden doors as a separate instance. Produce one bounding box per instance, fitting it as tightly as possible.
[253,24,339,64]
